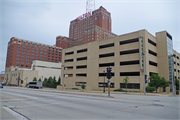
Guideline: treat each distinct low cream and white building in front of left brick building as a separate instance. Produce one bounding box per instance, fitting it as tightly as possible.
[3,60,61,85]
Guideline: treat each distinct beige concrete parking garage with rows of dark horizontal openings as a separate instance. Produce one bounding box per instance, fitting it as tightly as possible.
[61,30,179,91]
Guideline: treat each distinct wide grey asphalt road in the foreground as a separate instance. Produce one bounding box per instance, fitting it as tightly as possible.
[0,87,180,120]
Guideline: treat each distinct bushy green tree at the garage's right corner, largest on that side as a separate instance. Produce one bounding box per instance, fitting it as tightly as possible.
[149,74,169,93]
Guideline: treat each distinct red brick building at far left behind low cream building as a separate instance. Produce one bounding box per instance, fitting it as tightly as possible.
[6,37,61,68]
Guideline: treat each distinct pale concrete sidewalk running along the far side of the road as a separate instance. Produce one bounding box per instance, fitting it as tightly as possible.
[4,86,179,98]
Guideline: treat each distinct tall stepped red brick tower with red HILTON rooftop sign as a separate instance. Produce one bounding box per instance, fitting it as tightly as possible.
[56,6,117,48]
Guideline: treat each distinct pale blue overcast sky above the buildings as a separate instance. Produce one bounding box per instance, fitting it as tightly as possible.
[0,0,180,72]
